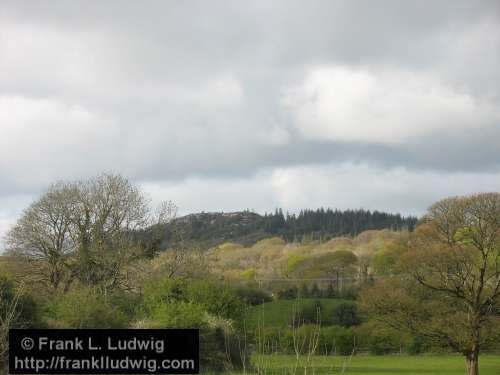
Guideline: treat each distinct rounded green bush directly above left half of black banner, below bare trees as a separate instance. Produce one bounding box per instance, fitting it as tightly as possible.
[48,288,127,328]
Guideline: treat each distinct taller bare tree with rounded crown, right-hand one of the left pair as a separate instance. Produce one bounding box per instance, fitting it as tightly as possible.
[69,174,149,287]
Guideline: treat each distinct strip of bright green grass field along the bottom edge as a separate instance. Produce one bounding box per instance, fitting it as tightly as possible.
[245,354,500,375]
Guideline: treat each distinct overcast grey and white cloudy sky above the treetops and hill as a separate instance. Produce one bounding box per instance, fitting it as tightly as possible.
[0,0,500,250]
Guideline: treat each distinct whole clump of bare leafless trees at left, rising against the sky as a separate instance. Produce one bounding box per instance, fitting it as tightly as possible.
[7,174,150,289]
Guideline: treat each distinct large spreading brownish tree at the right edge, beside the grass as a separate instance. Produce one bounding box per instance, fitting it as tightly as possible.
[362,193,500,375]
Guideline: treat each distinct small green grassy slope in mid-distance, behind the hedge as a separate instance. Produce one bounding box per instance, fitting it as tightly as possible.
[246,298,345,327]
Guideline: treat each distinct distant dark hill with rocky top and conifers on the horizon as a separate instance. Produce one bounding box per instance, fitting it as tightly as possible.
[139,208,417,253]
